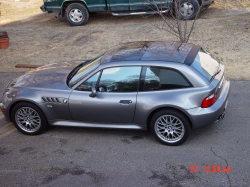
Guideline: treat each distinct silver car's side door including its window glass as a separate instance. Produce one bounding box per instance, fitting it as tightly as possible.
[69,66,141,124]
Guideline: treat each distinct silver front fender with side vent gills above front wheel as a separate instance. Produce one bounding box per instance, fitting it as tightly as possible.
[3,88,72,120]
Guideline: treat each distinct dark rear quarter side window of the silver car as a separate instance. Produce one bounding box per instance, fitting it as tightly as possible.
[143,67,191,91]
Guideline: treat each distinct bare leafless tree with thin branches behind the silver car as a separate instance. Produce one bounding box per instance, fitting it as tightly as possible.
[146,0,202,43]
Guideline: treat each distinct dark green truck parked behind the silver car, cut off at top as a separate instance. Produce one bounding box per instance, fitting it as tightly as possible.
[40,0,213,26]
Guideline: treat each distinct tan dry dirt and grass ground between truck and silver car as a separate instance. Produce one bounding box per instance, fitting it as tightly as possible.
[0,0,250,80]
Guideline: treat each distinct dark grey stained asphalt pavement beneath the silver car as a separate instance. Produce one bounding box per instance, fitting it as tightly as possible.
[0,73,250,187]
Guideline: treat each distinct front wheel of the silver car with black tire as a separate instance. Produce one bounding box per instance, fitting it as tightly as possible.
[11,102,48,135]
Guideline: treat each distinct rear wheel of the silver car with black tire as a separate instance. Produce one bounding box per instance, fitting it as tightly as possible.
[150,109,191,146]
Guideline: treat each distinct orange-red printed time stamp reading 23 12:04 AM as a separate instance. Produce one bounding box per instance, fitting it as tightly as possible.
[190,165,231,173]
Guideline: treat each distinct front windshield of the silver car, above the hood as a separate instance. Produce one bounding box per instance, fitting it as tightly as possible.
[69,56,102,87]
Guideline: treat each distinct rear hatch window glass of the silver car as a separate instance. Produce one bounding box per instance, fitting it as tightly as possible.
[191,48,220,81]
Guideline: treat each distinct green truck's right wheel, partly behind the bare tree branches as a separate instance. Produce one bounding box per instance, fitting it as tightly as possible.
[173,0,200,20]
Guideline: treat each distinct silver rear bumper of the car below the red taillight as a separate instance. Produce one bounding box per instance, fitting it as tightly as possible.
[187,80,230,128]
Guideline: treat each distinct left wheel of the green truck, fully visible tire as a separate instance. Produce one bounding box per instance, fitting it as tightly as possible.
[66,3,89,26]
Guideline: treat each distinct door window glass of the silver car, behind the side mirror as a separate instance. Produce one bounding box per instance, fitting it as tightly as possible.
[98,67,141,92]
